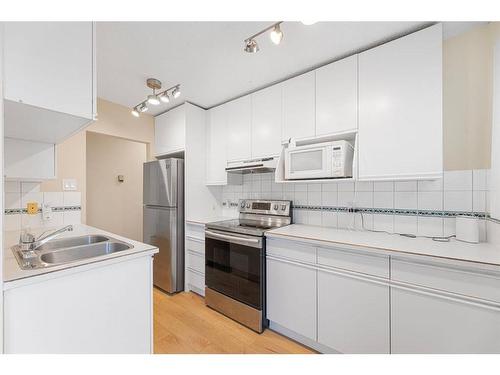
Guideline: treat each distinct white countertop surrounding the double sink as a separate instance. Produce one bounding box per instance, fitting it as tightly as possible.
[3,224,158,283]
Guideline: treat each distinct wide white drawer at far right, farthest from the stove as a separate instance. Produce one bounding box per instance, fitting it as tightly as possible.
[391,259,500,302]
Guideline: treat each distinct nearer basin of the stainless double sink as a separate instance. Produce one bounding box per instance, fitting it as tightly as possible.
[40,242,132,264]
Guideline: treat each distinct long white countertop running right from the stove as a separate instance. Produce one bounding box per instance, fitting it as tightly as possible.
[266,224,500,267]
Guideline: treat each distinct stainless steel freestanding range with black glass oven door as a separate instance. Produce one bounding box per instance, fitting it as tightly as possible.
[205,199,292,332]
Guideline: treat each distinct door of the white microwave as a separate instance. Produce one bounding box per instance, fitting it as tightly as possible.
[285,146,332,180]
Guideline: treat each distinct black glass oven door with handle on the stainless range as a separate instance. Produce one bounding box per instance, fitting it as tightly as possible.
[205,229,265,310]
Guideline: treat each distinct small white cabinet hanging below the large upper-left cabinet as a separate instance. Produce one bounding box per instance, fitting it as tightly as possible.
[4,138,56,181]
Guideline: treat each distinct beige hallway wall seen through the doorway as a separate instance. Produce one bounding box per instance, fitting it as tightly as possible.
[86,132,147,241]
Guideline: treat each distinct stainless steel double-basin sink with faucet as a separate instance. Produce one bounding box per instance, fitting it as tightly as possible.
[12,234,133,270]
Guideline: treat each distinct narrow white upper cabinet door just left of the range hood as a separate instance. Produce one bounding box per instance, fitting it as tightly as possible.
[206,106,227,185]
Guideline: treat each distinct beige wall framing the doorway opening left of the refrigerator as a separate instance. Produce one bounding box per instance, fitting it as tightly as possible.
[40,99,154,223]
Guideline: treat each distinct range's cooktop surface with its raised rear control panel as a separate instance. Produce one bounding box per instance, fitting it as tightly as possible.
[207,199,291,236]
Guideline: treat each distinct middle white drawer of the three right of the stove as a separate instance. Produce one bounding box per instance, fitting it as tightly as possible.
[318,247,389,278]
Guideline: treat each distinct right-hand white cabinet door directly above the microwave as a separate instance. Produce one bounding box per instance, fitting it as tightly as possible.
[316,55,358,135]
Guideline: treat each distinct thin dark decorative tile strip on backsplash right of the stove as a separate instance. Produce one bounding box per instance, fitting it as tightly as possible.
[293,205,486,223]
